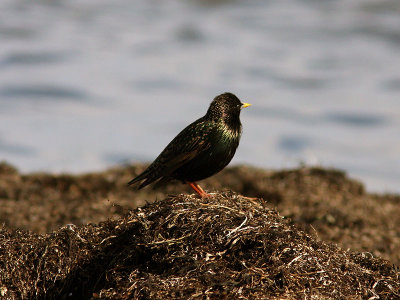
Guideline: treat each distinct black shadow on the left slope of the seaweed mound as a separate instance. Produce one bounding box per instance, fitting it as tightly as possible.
[46,222,153,299]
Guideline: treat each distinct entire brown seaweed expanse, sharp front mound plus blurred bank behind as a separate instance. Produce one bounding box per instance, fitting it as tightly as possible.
[0,163,400,299]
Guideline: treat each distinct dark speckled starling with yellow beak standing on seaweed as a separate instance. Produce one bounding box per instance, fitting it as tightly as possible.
[129,93,251,198]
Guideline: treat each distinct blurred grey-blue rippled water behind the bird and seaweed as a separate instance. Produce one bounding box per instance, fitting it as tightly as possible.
[0,0,400,192]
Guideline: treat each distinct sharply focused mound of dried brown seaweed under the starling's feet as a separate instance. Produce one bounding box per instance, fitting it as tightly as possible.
[0,192,400,299]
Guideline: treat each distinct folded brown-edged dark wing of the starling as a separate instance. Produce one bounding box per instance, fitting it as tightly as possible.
[129,119,212,188]
